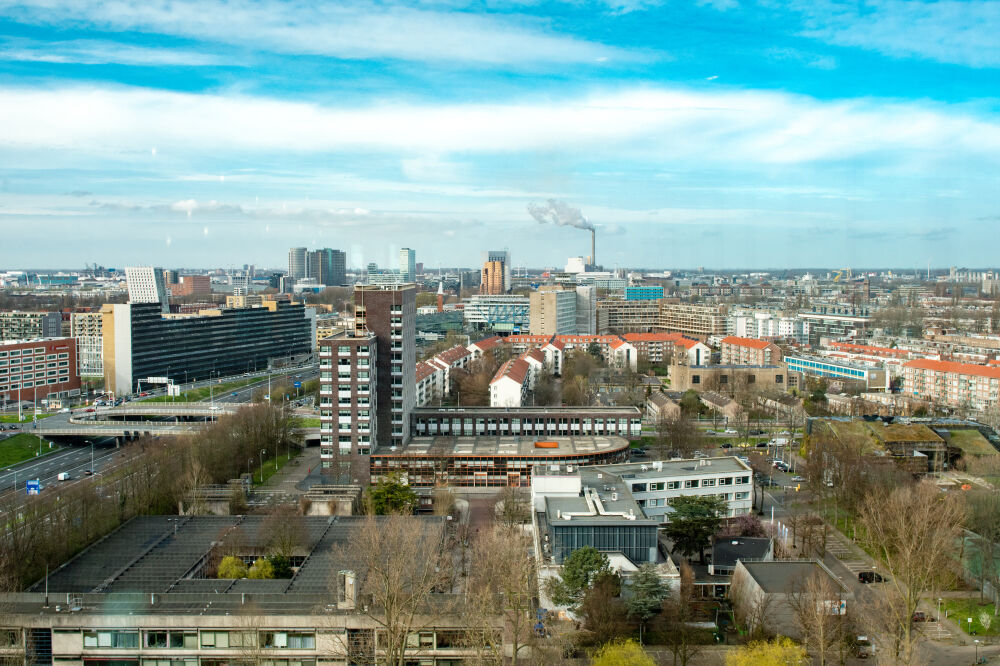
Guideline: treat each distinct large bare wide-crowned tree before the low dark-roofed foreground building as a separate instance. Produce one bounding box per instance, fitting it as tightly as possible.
[334,514,454,666]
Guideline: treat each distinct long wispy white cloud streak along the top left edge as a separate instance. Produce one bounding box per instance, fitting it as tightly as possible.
[0,0,646,65]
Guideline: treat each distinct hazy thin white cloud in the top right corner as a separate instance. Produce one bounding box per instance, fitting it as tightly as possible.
[796,0,1000,67]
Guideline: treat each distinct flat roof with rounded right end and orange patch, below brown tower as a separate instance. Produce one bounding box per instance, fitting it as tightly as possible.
[372,435,629,458]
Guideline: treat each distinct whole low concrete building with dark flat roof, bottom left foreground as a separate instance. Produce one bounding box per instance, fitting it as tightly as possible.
[0,516,496,666]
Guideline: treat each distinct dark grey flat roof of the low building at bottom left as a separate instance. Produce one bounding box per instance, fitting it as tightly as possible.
[27,516,440,613]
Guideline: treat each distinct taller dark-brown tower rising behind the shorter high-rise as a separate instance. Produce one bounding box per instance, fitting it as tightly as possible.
[354,284,417,448]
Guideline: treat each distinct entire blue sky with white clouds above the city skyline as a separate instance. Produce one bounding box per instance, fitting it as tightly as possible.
[0,0,1000,269]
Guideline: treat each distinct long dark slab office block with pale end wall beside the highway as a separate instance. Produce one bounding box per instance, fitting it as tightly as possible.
[101,301,315,395]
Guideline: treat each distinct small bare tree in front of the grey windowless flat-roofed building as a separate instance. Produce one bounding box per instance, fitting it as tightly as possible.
[788,571,847,666]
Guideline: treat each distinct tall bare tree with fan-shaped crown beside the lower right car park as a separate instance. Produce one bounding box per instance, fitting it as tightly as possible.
[859,482,963,664]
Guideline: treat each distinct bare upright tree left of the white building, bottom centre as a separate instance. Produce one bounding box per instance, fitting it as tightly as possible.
[468,524,536,666]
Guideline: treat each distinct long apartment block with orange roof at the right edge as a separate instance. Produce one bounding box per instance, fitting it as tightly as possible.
[902,359,1000,409]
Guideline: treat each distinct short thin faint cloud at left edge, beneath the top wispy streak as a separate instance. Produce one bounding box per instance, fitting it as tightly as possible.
[0,39,229,67]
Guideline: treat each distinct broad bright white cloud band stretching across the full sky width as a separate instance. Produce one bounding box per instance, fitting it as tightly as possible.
[0,87,1000,169]
